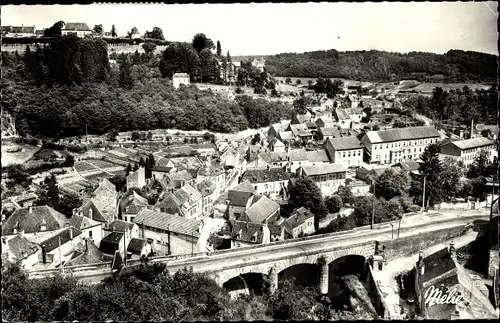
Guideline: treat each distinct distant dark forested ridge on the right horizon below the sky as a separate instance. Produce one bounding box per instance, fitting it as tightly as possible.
[266,49,497,82]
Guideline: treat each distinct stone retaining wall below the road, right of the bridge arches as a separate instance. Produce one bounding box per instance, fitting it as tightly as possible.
[381,225,467,261]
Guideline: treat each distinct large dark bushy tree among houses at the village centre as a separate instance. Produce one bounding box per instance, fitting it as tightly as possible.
[288,177,328,220]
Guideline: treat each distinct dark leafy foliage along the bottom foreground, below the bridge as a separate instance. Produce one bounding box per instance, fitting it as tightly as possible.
[2,261,368,322]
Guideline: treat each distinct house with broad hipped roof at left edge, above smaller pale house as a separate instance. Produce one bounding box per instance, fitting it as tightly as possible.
[2,205,66,237]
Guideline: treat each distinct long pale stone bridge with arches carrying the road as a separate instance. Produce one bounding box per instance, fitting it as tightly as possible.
[29,214,488,293]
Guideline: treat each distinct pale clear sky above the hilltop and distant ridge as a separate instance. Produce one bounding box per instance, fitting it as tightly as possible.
[1,1,498,56]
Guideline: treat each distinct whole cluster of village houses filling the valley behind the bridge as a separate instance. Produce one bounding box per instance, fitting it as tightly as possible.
[2,78,496,269]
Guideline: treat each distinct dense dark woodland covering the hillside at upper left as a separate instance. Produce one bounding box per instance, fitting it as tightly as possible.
[1,37,291,138]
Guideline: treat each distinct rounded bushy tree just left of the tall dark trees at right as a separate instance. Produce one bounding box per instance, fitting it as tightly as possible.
[375,168,410,200]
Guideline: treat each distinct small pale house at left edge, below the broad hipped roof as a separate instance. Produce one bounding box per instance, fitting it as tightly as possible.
[2,234,41,270]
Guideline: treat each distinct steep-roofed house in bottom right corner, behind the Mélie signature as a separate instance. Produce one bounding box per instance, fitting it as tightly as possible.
[413,243,498,320]
